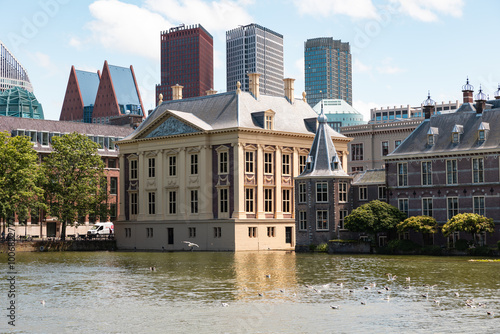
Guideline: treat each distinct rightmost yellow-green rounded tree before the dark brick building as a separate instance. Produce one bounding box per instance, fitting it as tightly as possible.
[442,213,495,236]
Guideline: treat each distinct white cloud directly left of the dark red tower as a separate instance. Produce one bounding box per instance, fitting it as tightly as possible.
[87,0,171,60]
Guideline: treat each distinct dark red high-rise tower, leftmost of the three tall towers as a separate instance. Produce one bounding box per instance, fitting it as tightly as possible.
[156,24,214,102]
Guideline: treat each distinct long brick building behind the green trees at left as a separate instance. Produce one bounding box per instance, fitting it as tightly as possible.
[0,116,133,238]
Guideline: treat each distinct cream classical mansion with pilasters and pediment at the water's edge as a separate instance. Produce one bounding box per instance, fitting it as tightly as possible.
[115,74,350,251]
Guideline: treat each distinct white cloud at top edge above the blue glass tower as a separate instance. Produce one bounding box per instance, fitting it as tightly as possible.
[293,0,378,19]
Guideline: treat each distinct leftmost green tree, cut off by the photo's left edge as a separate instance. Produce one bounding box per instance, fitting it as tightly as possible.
[0,132,45,235]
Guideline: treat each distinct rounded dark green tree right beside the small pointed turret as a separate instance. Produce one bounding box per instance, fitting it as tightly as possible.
[344,200,406,234]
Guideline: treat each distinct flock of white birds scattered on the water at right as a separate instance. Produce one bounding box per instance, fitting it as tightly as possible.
[221,273,494,316]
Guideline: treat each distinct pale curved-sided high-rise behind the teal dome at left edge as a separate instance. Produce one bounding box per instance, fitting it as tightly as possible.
[0,41,33,93]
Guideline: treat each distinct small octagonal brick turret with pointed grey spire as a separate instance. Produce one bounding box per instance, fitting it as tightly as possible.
[295,107,352,249]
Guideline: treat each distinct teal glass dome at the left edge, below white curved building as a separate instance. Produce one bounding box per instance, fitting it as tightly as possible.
[0,87,44,119]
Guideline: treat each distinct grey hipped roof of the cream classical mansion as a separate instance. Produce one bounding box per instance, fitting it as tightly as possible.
[126,91,347,139]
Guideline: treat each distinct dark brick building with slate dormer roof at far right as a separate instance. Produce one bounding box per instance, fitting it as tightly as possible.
[384,81,500,244]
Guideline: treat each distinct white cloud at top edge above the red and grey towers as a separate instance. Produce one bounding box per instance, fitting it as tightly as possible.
[145,0,253,33]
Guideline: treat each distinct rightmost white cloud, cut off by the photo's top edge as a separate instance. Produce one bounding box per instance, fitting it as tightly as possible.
[391,0,464,22]
